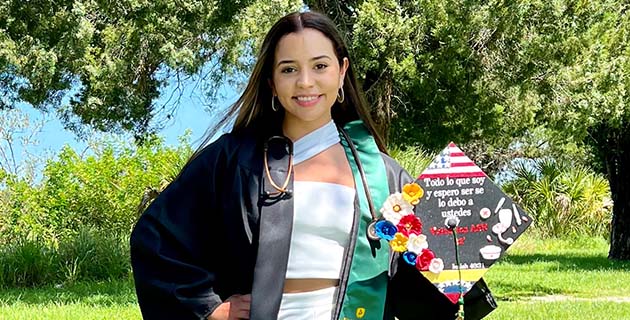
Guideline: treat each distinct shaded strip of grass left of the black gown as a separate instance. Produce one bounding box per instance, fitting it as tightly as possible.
[0,279,137,307]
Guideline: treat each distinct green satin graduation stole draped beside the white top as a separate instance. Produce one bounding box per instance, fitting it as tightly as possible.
[339,120,389,320]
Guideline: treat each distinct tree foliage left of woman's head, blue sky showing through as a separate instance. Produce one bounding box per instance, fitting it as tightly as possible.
[0,0,297,136]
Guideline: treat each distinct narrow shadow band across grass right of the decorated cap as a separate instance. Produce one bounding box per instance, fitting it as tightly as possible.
[501,253,630,271]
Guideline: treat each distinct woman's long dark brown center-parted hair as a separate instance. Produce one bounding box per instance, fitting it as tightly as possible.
[193,11,386,158]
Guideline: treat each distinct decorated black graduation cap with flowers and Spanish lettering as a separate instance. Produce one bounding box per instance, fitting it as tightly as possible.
[375,142,531,319]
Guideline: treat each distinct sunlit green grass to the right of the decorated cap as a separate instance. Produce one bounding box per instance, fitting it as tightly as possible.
[485,237,630,320]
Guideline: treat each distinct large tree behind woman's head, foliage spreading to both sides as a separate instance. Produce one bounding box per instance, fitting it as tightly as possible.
[0,0,518,164]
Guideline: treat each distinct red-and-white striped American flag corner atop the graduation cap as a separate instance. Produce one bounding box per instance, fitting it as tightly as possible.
[418,142,486,179]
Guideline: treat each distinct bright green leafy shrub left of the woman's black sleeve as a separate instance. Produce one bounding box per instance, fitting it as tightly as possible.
[0,133,192,287]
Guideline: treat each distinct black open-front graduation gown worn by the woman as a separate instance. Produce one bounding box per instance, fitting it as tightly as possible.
[130,134,496,320]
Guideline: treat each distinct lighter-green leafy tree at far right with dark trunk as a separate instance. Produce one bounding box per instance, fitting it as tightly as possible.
[462,0,630,260]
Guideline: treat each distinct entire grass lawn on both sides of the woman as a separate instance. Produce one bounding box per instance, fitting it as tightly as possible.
[0,236,630,320]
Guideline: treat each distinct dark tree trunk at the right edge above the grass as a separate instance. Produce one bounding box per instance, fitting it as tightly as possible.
[600,125,630,260]
